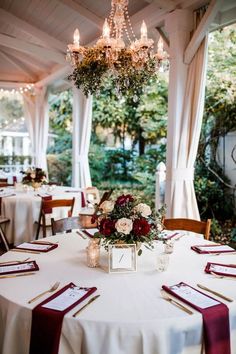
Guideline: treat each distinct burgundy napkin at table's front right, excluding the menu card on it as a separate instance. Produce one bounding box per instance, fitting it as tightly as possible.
[162,282,231,354]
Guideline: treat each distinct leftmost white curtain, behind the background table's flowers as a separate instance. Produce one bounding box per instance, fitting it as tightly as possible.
[23,87,49,171]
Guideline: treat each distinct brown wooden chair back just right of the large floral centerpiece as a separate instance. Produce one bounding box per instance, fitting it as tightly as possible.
[163,219,211,240]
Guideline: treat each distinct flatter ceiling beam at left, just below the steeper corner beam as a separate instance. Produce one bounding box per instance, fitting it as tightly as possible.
[0,34,65,64]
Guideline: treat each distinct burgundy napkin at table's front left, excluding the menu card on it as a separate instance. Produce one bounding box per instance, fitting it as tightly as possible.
[30,283,97,354]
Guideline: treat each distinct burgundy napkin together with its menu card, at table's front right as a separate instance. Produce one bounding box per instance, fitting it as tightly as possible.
[162,282,231,354]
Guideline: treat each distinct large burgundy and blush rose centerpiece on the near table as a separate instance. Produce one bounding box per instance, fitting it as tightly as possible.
[94,194,165,255]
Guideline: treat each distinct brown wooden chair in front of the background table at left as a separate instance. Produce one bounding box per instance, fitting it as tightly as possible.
[36,198,75,240]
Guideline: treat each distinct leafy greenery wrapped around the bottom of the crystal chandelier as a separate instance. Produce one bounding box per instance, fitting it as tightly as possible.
[69,48,157,99]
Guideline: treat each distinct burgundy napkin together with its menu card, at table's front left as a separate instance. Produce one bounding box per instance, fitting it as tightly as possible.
[30,283,97,354]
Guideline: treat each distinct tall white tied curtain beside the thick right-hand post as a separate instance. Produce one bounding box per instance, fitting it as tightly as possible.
[166,9,207,220]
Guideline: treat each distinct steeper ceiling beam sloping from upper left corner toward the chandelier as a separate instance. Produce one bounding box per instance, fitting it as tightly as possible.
[0,9,66,53]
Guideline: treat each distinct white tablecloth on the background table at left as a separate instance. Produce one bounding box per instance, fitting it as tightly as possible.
[2,187,81,245]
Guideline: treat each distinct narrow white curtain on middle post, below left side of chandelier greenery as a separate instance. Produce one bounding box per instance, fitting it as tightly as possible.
[72,88,92,188]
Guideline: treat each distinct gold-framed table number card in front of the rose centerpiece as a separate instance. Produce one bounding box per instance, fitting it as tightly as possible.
[108,244,137,273]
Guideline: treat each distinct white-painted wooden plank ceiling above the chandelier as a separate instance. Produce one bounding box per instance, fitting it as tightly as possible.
[0,0,236,87]
